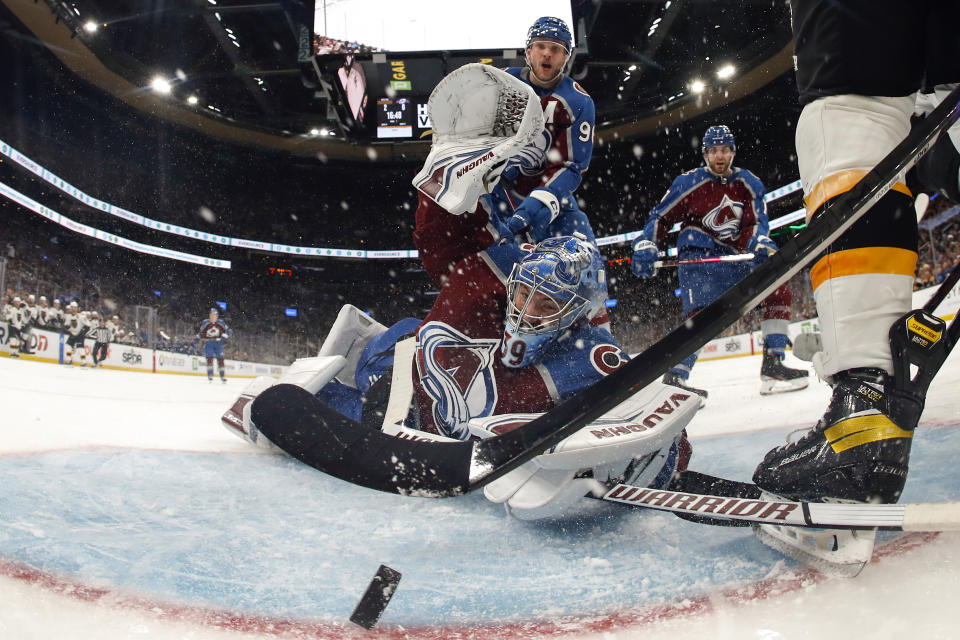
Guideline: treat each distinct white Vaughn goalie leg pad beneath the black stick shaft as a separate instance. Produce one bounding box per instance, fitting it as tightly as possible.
[478,382,700,520]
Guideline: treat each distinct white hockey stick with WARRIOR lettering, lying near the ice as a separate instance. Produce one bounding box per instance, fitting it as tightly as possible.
[603,483,960,531]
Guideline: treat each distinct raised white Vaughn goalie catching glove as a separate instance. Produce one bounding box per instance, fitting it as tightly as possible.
[413,63,544,215]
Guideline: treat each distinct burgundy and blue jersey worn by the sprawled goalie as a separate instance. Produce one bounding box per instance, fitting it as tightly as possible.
[413,195,628,439]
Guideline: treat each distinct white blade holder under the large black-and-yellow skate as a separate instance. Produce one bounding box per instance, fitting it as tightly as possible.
[753,524,877,578]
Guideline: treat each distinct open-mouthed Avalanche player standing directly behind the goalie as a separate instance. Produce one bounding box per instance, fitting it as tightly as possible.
[493,17,596,243]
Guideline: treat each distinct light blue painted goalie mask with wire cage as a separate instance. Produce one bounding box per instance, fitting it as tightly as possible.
[500,233,607,367]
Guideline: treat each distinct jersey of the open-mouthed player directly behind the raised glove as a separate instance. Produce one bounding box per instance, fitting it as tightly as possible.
[494,67,594,212]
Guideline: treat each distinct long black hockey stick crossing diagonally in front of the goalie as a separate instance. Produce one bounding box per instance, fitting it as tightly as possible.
[252,89,960,497]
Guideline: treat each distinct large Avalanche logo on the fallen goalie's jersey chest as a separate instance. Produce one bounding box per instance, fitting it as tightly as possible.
[417,322,500,440]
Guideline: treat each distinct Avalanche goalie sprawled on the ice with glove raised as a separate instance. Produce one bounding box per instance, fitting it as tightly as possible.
[229,65,699,519]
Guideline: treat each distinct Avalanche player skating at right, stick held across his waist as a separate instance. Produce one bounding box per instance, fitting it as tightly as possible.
[630,125,808,398]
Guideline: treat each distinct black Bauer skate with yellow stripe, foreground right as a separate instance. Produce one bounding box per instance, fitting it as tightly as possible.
[753,296,960,577]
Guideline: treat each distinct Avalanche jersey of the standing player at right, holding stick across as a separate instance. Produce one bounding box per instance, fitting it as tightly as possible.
[643,167,770,253]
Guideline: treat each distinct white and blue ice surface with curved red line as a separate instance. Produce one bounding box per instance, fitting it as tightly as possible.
[0,354,960,640]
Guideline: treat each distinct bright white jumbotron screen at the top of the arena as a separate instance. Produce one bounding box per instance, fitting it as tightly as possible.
[313,0,573,55]
